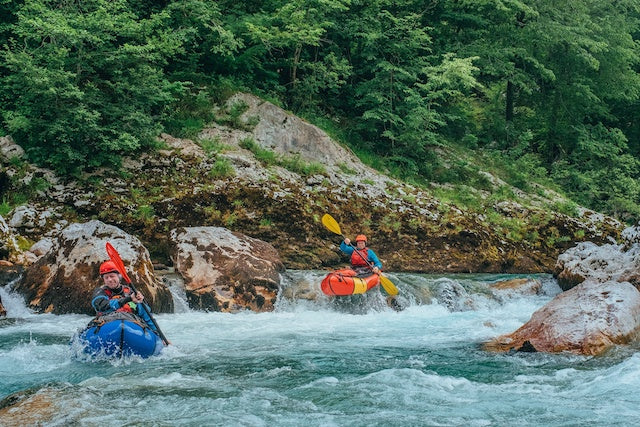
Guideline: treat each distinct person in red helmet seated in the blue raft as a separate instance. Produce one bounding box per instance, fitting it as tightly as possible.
[91,261,157,333]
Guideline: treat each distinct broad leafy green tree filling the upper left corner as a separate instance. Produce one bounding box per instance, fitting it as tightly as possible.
[1,0,182,172]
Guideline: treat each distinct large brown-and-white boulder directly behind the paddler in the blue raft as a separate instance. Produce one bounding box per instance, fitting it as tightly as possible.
[15,220,173,314]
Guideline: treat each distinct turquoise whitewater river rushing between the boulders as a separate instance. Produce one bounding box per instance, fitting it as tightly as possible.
[0,272,640,426]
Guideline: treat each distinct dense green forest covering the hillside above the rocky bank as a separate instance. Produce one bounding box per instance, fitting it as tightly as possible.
[0,0,640,221]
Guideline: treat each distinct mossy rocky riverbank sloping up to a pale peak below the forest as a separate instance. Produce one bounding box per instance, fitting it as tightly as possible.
[0,94,623,272]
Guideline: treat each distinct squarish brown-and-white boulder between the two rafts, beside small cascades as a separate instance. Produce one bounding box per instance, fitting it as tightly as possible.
[170,227,284,312]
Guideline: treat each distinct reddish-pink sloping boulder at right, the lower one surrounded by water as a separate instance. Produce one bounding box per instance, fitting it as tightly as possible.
[485,281,640,355]
